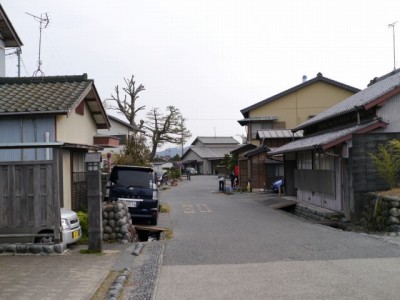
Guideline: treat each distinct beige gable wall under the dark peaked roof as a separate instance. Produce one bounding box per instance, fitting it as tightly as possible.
[249,82,354,129]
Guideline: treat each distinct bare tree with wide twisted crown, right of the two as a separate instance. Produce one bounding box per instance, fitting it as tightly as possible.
[143,106,191,161]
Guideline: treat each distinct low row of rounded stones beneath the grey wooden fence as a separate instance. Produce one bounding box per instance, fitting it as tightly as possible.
[0,243,66,255]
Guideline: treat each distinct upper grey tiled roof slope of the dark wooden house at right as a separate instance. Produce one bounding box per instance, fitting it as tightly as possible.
[293,72,400,131]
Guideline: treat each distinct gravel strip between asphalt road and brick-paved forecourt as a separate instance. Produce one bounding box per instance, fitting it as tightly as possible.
[122,241,165,300]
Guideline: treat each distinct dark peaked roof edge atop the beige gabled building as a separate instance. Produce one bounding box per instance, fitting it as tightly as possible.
[240,73,359,118]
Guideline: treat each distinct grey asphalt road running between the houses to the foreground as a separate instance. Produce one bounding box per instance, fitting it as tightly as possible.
[156,176,400,300]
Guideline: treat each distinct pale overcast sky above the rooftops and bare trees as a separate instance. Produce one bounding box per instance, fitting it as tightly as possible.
[0,0,400,149]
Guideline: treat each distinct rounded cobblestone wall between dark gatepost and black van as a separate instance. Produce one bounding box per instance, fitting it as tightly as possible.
[103,201,137,243]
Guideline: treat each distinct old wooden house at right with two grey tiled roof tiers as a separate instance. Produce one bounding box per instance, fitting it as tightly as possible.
[268,70,400,220]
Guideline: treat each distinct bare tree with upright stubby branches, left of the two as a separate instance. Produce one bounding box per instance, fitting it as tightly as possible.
[103,75,146,127]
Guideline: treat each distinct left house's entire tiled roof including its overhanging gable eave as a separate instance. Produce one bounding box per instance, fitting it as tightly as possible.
[0,74,110,129]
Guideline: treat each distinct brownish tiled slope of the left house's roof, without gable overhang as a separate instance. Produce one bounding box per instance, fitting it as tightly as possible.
[0,77,92,115]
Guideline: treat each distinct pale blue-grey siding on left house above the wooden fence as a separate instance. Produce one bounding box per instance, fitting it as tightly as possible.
[0,116,55,161]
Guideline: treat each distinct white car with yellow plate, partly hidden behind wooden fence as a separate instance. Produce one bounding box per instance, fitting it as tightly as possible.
[35,208,82,245]
